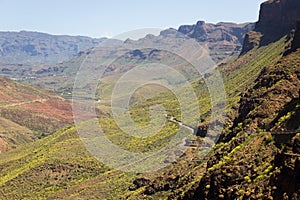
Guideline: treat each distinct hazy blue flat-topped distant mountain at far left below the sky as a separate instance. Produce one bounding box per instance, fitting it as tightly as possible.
[0,31,106,64]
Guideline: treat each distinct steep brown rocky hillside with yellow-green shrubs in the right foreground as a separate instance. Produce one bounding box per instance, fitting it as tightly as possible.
[188,50,300,199]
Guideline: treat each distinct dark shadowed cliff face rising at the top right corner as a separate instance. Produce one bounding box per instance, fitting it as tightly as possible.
[241,0,300,54]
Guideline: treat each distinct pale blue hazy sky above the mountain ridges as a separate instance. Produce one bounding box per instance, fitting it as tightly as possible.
[0,0,264,37]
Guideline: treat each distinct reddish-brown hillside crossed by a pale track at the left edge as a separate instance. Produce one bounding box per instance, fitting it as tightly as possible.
[0,78,73,152]
